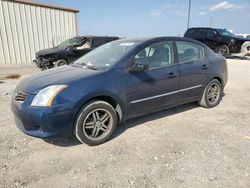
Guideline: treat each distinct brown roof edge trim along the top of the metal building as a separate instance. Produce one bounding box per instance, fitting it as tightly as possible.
[11,0,79,13]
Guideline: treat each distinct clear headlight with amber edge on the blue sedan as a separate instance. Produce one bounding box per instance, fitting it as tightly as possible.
[31,85,68,107]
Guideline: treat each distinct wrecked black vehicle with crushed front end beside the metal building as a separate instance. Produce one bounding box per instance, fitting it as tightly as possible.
[33,36,119,70]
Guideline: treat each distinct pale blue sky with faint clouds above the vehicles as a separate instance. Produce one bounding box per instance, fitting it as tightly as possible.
[34,0,250,37]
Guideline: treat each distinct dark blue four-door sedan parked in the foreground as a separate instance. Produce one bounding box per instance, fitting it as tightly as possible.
[11,37,227,145]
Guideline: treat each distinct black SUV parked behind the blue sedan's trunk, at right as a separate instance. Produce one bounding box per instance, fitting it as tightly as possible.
[184,27,250,56]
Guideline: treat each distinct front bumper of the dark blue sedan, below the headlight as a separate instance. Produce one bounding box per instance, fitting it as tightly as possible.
[11,95,74,138]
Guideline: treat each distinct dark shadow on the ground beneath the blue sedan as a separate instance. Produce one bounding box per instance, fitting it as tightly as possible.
[43,102,199,147]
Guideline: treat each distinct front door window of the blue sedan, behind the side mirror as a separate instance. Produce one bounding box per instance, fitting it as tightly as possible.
[132,41,174,69]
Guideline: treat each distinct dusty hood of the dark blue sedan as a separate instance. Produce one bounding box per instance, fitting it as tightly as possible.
[15,66,102,94]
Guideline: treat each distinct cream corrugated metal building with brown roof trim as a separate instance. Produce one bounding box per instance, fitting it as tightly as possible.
[0,0,79,64]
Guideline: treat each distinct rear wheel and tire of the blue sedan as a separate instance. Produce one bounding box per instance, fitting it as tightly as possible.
[199,79,223,108]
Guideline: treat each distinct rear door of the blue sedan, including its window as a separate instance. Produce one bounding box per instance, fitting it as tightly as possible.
[176,41,209,101]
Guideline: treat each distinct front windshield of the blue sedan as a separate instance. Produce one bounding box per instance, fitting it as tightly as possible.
[74,41,138,69]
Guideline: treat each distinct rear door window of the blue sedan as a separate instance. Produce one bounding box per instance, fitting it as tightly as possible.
[176,42,205,63]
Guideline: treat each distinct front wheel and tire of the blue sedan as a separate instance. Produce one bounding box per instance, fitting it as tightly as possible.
[74,101,118,146]
